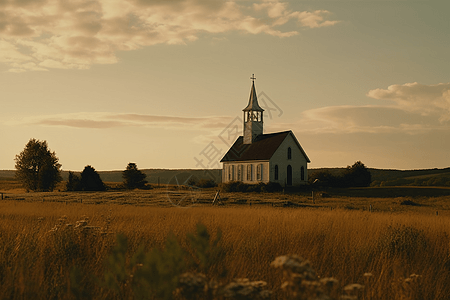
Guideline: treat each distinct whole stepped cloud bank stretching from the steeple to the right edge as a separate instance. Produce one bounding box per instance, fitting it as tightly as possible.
[271,82,450,134]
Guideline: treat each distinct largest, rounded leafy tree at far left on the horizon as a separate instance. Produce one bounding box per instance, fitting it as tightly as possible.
[14,139,62,192]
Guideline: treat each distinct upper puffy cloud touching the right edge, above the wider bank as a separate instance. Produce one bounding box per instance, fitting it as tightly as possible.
[367,82,450,123]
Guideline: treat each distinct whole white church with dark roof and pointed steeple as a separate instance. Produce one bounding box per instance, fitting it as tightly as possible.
[220,77,311,186]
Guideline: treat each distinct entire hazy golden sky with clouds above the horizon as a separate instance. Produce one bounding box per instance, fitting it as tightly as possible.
[0,0,450,171]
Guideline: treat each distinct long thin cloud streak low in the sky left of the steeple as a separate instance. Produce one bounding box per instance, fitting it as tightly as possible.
[14,113,236,130]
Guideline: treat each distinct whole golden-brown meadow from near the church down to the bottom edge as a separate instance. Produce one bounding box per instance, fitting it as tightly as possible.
[0,186,450,299]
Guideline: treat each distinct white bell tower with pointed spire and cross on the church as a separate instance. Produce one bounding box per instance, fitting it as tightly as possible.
[242,74,264,144]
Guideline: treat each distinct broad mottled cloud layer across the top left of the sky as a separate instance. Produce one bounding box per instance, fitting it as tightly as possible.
[0,0,337,72]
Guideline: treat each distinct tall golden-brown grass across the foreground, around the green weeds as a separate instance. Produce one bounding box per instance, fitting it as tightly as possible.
[0,201,450,299]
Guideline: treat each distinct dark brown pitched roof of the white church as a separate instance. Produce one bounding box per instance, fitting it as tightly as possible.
[220,130,310,162]
